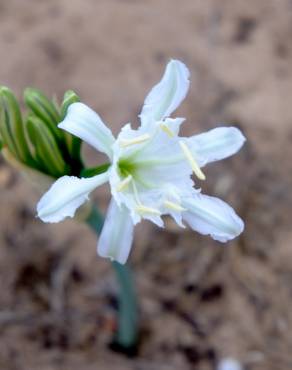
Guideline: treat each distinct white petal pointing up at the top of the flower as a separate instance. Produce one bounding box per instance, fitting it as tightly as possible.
[141,60,190,125]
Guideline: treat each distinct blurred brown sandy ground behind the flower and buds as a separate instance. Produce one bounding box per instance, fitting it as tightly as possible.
[0,0,292,370]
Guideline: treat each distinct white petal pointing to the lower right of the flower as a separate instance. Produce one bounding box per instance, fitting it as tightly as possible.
[182,194,244,242]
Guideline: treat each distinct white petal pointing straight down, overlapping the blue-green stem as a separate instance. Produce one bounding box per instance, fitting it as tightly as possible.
[97,198,134,264]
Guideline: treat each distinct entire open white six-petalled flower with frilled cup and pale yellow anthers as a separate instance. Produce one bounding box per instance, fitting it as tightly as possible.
[37,60,245,263]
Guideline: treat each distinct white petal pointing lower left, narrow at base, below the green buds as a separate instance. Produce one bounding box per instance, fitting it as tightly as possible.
[37,172,108,222]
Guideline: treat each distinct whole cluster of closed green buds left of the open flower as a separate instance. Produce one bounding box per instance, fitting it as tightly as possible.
[0,87,83,178]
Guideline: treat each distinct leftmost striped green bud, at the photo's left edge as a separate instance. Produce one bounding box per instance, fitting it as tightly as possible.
[0,86,31,163]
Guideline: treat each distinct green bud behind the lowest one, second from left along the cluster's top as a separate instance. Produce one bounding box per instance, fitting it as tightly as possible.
[24,87,63,142]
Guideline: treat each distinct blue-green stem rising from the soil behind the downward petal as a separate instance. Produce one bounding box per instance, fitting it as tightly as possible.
[86,207,138,349]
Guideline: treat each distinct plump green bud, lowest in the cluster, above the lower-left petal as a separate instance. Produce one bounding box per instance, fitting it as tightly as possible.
[26,116,69,177]
